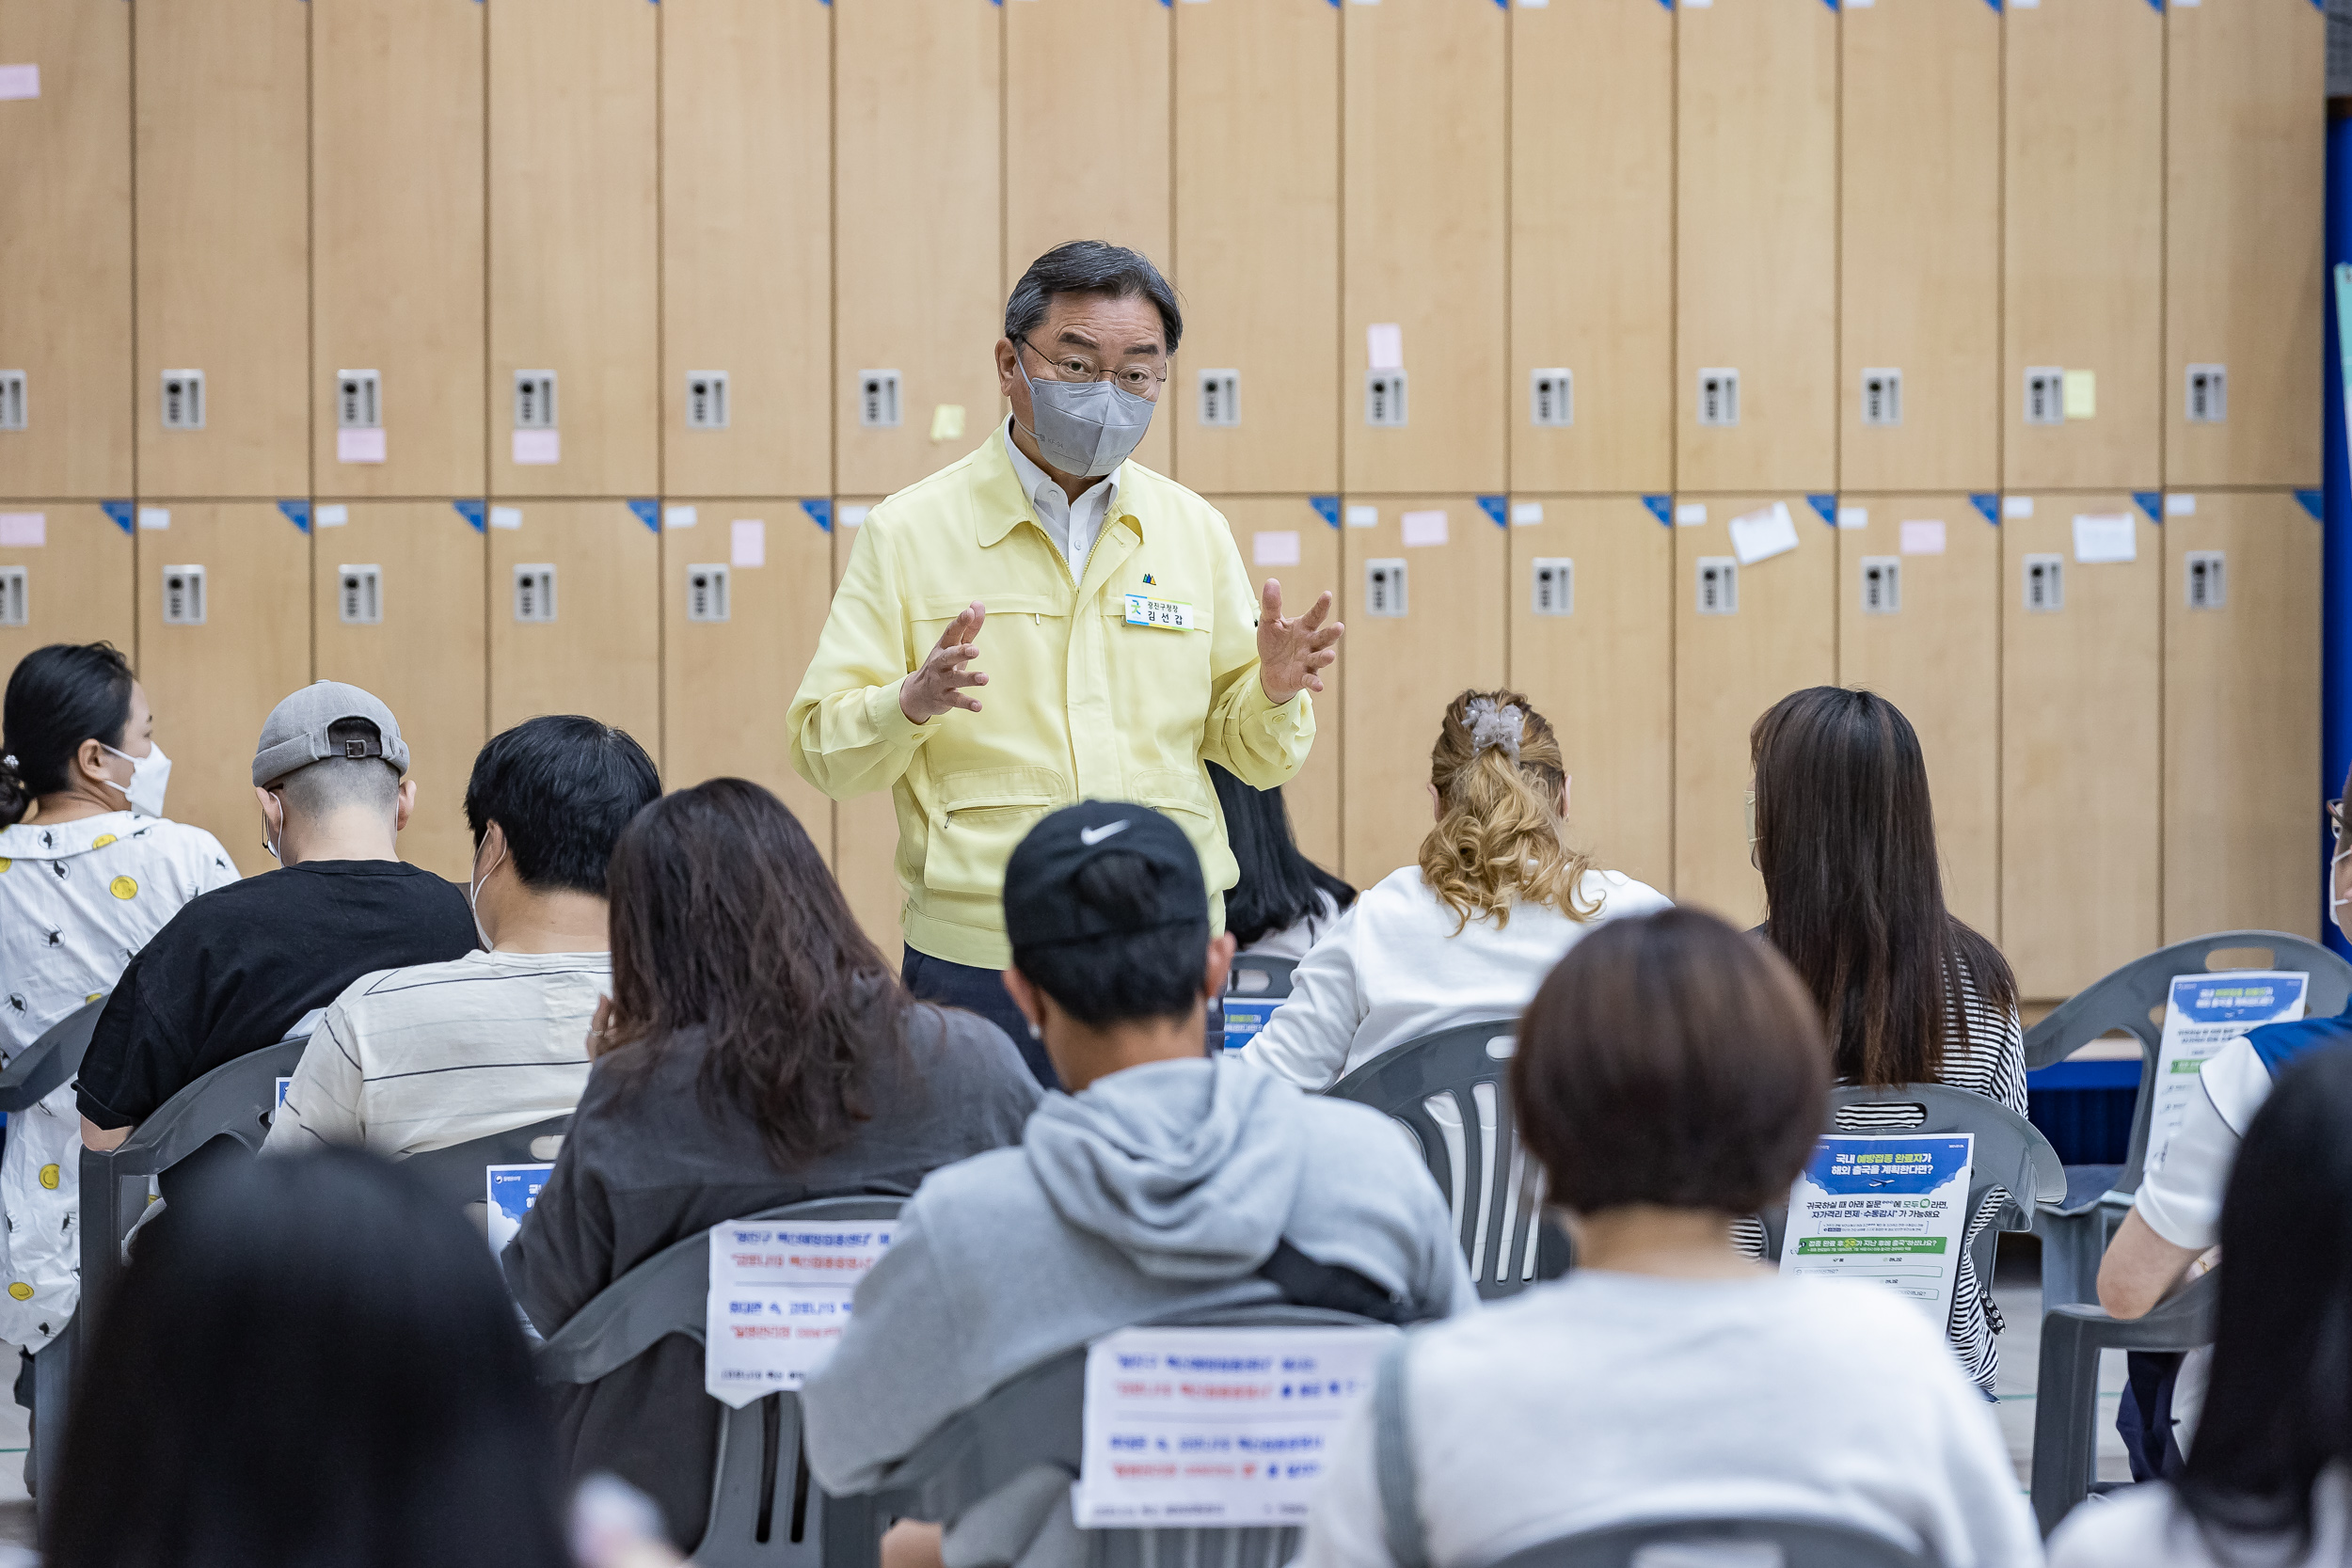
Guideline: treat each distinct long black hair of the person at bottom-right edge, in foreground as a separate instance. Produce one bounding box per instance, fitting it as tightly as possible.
[2178,1049,2352,1561]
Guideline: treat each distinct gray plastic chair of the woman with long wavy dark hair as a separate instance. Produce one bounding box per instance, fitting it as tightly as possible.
[538,1194,906,1568]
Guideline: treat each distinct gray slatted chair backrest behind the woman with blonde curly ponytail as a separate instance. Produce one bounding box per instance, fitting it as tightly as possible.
[1331,1018,1569,1300]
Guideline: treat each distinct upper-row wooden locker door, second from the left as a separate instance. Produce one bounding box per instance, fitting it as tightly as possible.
[132,0,310,500]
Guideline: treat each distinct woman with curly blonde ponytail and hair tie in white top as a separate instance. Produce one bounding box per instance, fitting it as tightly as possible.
[1242,691,1670,1088]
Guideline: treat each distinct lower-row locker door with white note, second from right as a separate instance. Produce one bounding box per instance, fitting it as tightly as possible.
[2002,496,2164,1002]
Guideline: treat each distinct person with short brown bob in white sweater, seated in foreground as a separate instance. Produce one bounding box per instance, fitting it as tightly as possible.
[1298,910,2042,1568]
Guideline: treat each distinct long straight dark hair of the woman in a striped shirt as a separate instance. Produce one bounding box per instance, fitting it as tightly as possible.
[1748,687,2018,1084]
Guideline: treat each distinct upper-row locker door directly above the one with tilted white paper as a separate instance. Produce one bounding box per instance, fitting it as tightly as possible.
[1675,0,1844,491]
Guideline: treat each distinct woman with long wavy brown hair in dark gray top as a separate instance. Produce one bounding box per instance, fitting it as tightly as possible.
[506,778,1040,1552]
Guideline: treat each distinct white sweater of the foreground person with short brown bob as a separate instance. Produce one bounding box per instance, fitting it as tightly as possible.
[1294,1270,2042,1568]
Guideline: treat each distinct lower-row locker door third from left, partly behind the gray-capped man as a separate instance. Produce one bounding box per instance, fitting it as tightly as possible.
[310,500,489,881]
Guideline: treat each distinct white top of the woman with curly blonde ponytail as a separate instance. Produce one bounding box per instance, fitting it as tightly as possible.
[1242,865,1673,1091]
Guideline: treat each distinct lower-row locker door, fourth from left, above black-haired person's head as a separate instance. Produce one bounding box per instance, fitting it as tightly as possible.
[489,500,661,754]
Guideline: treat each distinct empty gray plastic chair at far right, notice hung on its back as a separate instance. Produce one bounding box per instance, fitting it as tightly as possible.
[2026,931,2352,1312]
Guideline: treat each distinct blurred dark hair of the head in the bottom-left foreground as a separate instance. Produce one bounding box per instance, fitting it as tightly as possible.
[42,1149,569,1568]
